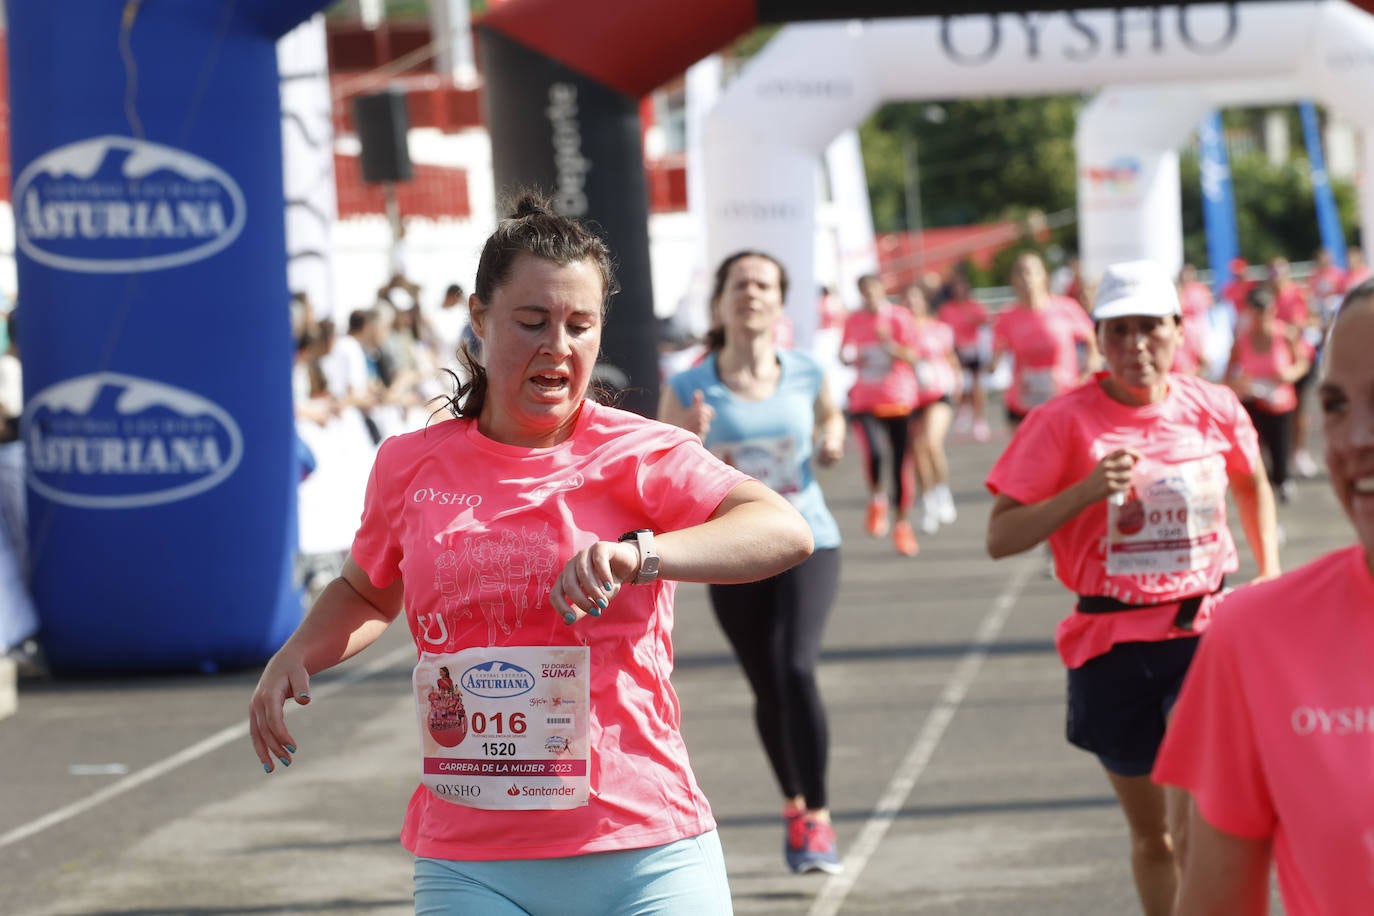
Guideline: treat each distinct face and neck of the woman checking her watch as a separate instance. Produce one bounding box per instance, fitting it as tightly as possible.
[471,254,605,448]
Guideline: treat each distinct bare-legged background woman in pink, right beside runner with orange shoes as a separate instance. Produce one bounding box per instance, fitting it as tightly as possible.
[901,283,963,534]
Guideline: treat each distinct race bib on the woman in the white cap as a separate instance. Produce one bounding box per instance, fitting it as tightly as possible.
[1107,457,1226,575]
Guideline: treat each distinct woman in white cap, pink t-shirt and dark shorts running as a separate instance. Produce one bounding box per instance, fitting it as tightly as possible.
[987,261,1279,916]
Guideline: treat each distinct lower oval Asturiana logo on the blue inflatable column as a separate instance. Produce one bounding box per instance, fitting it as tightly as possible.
[23,372,243,509]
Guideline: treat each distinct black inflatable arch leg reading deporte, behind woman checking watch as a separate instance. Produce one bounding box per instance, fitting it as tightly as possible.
[478,27,658,416]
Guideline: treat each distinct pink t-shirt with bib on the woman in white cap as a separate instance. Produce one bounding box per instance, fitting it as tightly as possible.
[987,372,1260,667]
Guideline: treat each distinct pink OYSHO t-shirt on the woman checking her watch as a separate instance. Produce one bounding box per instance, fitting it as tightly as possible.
[353,401,749,860]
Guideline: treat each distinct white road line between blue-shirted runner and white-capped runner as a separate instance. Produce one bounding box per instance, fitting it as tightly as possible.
[808,551,1044,916]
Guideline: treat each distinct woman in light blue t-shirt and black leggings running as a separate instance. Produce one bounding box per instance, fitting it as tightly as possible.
[658,251,845,873]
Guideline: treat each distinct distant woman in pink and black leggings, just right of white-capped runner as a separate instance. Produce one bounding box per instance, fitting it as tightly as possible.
[1226,284,1309,503]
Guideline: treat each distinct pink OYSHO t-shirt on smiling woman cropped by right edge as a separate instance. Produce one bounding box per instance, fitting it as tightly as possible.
[1154,545,1374,916]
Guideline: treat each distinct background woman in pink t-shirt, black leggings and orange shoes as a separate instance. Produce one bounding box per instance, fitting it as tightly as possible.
[840,275,918,556]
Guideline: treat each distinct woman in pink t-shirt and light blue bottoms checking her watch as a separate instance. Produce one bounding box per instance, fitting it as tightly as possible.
[249,189,812,916]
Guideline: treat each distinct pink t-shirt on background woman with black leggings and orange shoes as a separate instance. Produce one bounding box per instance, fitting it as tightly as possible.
[841,302,916,416]
